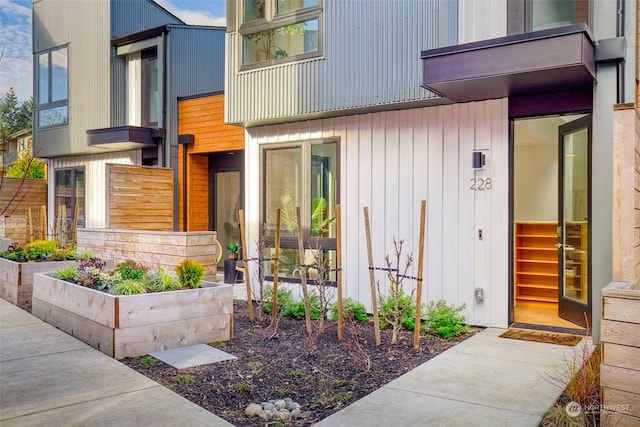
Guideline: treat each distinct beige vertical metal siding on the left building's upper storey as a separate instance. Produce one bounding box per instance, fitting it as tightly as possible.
[33,0,111,157]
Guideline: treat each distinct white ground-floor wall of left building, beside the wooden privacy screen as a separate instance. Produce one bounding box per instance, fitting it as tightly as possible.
[47,150,142,230]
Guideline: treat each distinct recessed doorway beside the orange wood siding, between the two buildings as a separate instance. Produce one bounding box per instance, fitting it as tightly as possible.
[209,151,244,269]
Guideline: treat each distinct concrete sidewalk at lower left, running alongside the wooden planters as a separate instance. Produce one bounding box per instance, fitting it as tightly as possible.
[0,299,231,427]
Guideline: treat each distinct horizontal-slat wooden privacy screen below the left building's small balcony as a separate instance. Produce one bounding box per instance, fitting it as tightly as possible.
[106,164,173,231]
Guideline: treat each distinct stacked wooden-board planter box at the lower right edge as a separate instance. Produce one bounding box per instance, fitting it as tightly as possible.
[600,282,640,427]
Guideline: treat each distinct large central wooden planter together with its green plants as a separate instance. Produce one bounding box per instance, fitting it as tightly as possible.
[32,258,233,359]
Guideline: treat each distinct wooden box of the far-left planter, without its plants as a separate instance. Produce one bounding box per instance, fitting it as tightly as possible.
[0,258,75,309]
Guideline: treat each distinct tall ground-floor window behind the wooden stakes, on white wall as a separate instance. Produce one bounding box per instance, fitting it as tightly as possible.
[262,141,339,280]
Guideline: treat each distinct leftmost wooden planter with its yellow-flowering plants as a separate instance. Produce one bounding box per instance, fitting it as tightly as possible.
[0,240,76,309]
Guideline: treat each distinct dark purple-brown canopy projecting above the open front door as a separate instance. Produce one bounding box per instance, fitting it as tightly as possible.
[421,24,596,102]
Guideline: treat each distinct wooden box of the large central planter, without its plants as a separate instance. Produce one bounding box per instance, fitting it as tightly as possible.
[32,274,233,359]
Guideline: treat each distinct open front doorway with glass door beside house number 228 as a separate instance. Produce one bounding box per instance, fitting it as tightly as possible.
[512,114,591,329]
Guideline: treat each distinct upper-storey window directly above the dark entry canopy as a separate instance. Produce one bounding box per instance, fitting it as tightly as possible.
[507,0,590,35]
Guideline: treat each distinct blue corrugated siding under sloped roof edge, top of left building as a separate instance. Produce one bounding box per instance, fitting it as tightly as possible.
[110,0,184,38]
